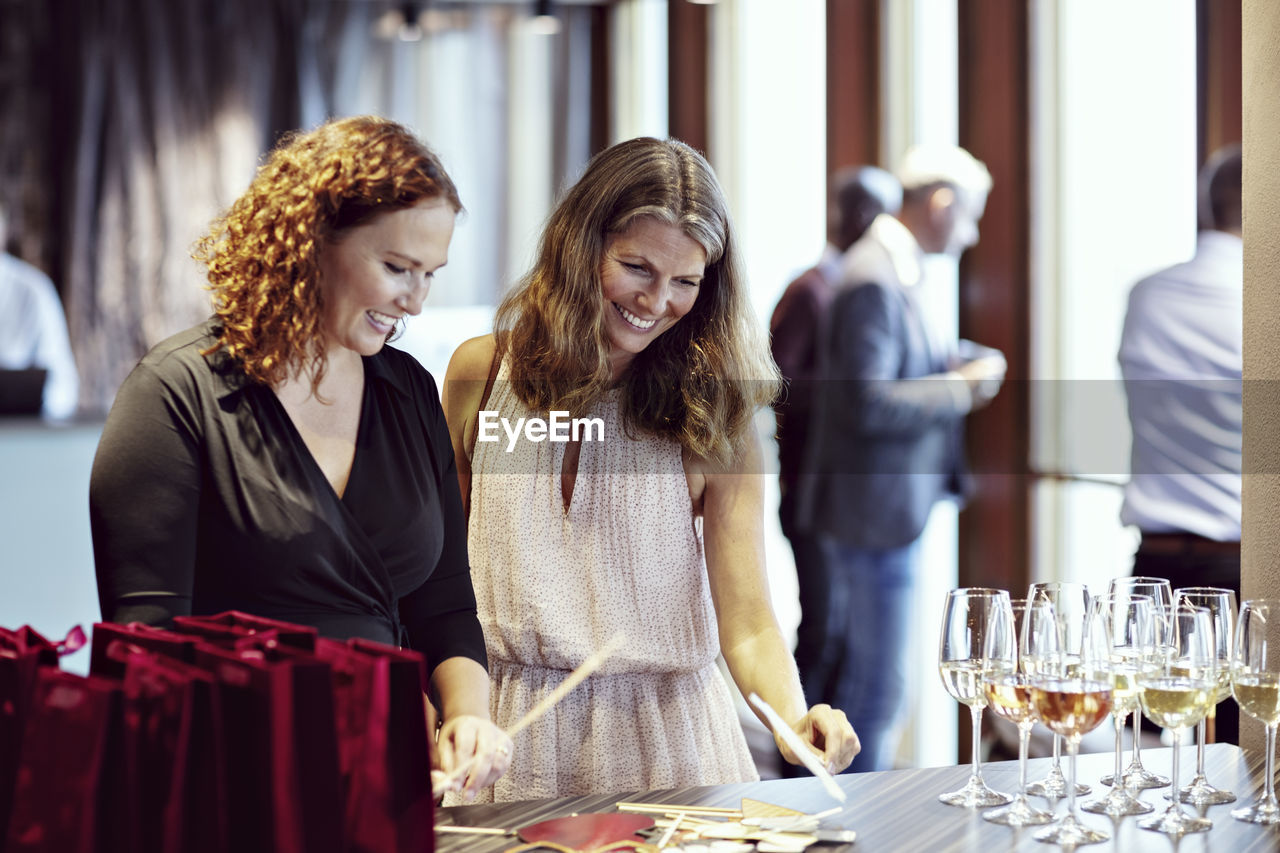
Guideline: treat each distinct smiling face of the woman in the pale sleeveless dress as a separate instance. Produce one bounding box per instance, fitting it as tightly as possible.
[600,216,707,379]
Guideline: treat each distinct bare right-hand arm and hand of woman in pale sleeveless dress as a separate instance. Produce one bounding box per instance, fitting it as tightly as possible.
[700,430,860,772]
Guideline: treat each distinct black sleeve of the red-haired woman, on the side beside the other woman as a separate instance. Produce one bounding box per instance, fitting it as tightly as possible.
[399,371,489,669]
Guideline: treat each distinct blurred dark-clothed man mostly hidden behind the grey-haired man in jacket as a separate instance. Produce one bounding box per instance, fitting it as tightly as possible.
[769,165,902,722]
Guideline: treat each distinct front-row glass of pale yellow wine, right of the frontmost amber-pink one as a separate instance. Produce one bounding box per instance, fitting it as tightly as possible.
[1138,603,1217,838]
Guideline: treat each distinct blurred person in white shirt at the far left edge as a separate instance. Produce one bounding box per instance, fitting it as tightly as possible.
[0,207,79,418]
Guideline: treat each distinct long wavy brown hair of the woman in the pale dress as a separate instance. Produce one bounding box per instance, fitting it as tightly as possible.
[494,137,780,464]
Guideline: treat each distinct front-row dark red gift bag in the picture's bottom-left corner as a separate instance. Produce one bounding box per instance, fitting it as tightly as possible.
[5,667,129,853]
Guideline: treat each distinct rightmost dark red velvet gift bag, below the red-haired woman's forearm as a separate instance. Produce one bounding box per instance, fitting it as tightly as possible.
[316,639,435,853]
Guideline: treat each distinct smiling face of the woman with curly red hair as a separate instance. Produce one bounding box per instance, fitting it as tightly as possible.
[320,199,457,356]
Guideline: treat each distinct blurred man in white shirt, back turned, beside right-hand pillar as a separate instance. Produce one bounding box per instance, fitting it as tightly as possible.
[1120,145,1244,742]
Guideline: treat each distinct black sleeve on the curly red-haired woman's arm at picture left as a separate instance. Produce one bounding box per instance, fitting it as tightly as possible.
[90,364,201,625]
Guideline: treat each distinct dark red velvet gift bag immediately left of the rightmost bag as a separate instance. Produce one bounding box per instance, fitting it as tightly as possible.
[196,644,343,853]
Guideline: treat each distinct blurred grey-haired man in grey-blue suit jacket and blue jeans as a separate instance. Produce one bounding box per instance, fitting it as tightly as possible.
[799,146,1005,771]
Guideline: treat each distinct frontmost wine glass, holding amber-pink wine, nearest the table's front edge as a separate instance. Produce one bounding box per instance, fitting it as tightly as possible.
[1028,596,1114,848]
